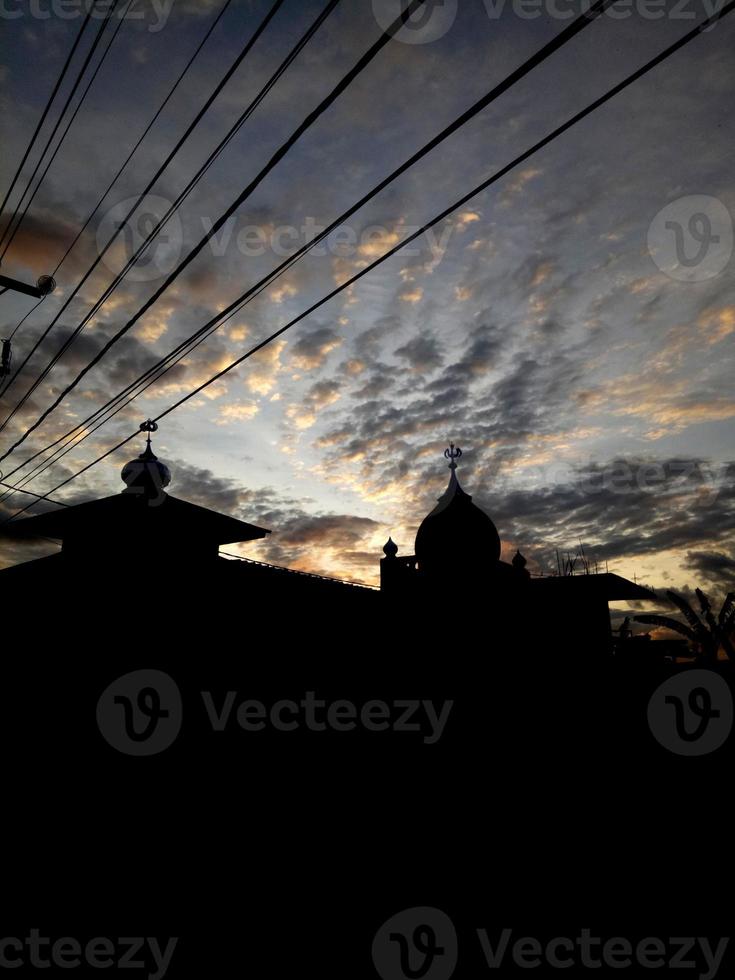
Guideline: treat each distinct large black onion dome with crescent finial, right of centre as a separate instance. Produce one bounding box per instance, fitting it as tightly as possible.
[415,445,500,574]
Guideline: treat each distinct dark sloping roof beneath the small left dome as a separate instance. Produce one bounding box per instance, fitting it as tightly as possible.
[4,492,270,544]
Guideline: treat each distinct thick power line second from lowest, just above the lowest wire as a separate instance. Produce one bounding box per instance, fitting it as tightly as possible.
[0,0,613,494]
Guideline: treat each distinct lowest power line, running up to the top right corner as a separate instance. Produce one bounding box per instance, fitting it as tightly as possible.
[4,0,735,520]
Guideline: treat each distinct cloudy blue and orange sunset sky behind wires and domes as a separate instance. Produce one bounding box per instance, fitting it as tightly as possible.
[0,0,735,612]
